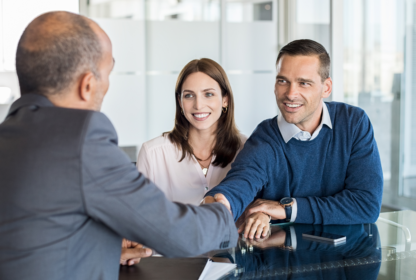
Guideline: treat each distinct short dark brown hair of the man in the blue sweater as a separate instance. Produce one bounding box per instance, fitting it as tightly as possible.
[276,39,331,82]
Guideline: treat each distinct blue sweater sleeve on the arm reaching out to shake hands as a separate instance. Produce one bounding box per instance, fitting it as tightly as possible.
[205,122,276,220]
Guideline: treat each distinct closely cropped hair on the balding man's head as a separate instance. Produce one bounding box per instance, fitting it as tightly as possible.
[16,12,102,96]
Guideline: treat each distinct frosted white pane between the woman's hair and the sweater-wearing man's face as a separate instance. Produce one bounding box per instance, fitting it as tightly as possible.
[224,21,278,136]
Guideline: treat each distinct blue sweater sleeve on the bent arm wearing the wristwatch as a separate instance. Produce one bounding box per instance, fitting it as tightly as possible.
[296,113,383,224]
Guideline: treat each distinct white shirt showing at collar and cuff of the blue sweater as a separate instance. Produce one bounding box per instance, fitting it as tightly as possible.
[277,102,332,222]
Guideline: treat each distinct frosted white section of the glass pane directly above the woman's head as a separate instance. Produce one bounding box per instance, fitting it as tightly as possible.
[146,21,220,140]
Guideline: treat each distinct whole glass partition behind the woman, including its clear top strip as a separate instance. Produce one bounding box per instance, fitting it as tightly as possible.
[83,0,278,151]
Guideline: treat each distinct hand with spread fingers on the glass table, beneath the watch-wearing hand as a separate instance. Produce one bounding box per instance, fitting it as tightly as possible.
[238,212,270,239]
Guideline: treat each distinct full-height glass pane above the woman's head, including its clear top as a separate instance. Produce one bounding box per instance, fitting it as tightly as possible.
[144,0,221,140]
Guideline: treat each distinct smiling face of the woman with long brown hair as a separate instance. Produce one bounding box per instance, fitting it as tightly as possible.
[179,72,228,132]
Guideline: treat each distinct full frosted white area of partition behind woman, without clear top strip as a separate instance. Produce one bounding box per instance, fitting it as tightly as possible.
[97,2,278,146]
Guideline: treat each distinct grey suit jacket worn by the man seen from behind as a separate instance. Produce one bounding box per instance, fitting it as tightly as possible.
[0,94,238,280]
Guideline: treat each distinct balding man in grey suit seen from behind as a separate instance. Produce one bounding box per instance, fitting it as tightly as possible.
[0,12,238,280]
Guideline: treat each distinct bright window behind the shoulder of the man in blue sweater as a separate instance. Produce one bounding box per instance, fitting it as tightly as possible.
[344,0,416,208]
